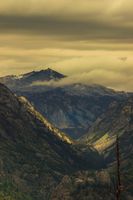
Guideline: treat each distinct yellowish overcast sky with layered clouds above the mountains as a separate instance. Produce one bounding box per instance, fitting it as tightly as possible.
[0,0,133,91]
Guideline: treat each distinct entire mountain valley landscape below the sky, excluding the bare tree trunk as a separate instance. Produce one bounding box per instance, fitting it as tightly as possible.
[0,69,133,200]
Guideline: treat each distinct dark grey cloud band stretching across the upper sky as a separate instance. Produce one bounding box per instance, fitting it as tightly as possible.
[0,15,133,42]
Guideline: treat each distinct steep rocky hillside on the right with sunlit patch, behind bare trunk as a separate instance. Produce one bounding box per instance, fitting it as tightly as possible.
[82,97,133,196]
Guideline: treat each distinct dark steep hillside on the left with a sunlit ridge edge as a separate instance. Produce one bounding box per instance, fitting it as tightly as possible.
[0,84,102,200]
